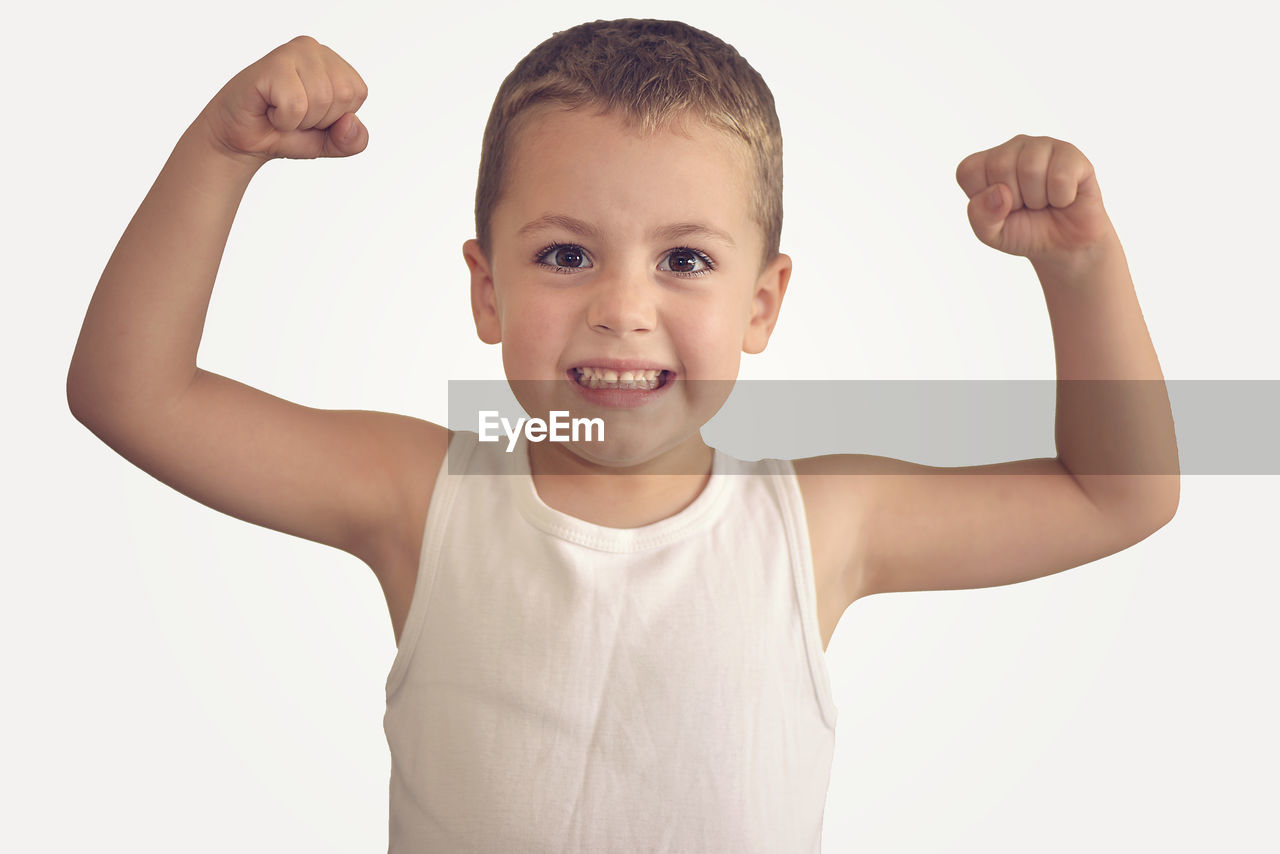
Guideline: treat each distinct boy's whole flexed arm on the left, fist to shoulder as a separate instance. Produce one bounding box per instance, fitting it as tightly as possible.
[67,36,447,578]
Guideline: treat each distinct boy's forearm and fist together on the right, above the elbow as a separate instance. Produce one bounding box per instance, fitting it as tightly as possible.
[956,136,1179,517]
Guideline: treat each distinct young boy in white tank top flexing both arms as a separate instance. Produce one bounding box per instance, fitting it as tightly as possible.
[68,20,1178,853]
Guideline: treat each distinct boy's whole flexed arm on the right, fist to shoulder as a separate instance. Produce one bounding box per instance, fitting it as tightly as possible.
[796,136,1179,603]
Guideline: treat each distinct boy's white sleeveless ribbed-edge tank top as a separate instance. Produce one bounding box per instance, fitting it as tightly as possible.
[384,433,836,854]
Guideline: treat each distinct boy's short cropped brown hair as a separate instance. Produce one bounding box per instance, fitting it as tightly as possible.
[476,18,782,262]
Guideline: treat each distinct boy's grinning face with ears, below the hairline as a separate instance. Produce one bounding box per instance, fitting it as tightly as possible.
[463,105,791,466]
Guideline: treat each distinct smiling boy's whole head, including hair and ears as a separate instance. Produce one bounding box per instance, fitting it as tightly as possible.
[463,20,791,467]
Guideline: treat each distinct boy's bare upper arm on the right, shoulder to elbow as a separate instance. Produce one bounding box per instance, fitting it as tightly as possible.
[828,455,1167,599]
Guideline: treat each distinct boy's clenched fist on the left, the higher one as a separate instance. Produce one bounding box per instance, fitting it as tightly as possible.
[197,36,369,161]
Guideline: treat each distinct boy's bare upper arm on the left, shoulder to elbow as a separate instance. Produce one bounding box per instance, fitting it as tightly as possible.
[81,369,448,563]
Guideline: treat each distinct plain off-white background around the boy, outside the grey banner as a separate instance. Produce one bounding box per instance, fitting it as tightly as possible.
[0,0,1280,854]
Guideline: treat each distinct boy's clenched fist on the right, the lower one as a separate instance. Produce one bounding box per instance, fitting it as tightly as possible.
[956,134,1114,262]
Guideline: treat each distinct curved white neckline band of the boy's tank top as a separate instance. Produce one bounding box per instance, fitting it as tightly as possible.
[504,435,732,552]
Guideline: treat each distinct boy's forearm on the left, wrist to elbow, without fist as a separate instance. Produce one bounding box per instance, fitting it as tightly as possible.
[67,119,262,419]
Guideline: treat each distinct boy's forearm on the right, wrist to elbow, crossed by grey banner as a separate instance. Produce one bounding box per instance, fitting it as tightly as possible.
[1033,232,1179,524]
